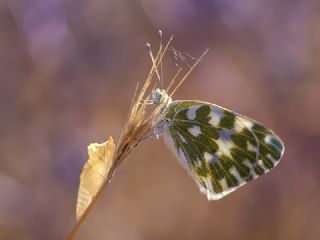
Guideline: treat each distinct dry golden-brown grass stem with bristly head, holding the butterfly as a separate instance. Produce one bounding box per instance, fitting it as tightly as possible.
[68,37,208,240]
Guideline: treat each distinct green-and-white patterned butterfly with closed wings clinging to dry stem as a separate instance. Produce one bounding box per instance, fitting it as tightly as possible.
[152,88,285,200]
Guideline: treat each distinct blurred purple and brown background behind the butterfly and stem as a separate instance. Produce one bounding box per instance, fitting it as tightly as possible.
[0,0,320,240]
